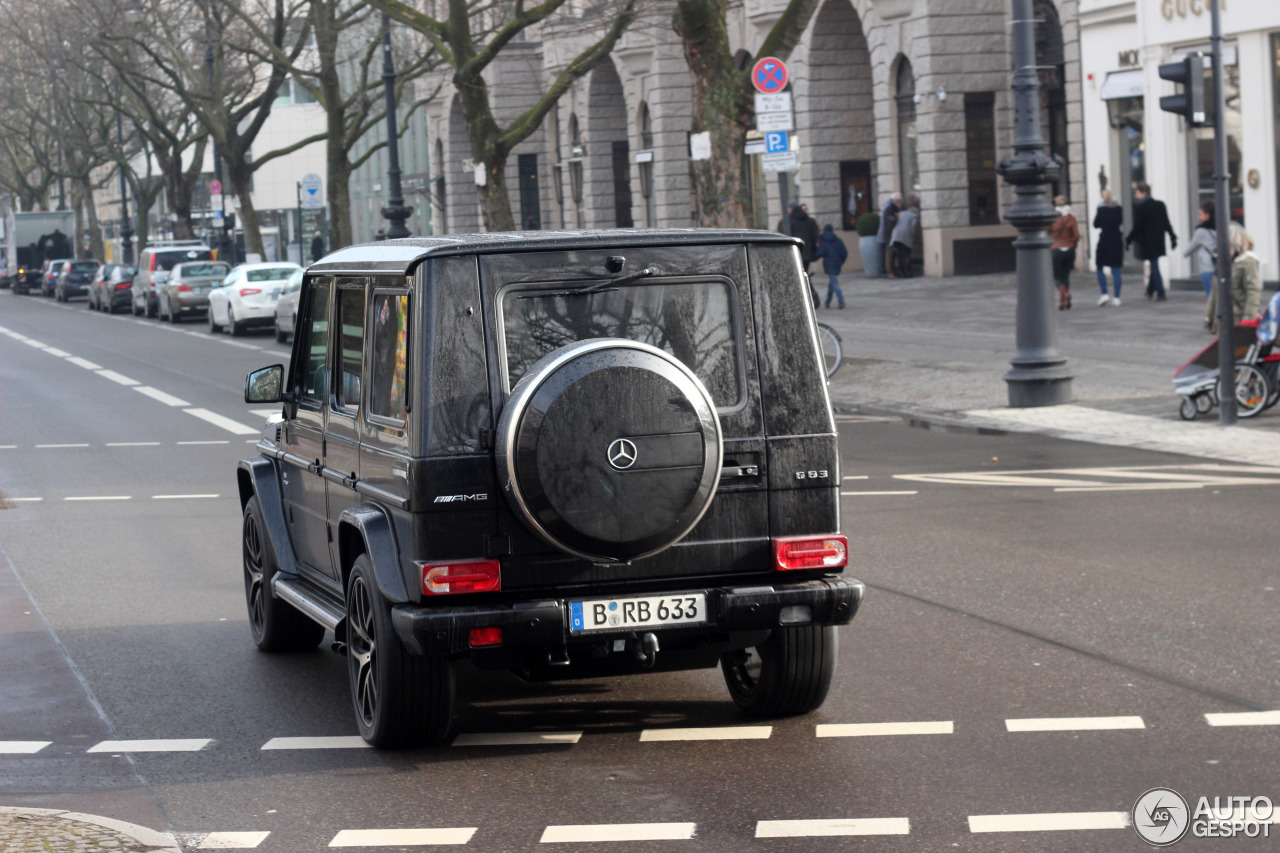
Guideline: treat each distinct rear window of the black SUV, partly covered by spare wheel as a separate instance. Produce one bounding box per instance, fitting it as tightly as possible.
[502,280,741,409]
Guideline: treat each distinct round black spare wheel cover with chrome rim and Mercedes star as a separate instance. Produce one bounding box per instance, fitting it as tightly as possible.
[497,338,722,562]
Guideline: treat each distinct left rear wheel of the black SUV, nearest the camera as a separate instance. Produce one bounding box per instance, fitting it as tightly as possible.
[347,555,454,748]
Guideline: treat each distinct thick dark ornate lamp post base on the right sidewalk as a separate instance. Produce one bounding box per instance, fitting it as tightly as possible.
[997,0,1071,409]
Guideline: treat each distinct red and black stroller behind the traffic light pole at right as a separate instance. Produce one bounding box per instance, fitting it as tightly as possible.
[1174,293,1280,420]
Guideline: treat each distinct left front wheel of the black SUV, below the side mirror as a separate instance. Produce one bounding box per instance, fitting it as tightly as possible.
[241,497,324,652]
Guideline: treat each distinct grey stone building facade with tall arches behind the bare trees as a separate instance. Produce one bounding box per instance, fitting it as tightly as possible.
[414,0,1084,275]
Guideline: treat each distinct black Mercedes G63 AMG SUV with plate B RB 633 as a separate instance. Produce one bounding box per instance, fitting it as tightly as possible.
[238,229,863,747]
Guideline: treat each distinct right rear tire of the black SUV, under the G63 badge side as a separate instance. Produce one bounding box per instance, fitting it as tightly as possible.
[721,625,837,717]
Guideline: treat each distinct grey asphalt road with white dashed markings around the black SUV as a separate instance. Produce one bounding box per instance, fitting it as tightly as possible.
[0,292,1280,853]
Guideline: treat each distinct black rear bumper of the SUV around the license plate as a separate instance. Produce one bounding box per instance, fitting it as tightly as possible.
[392,576,865,656]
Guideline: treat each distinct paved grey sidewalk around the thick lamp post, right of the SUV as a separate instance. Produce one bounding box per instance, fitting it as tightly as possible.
[815,267,1280,465]
